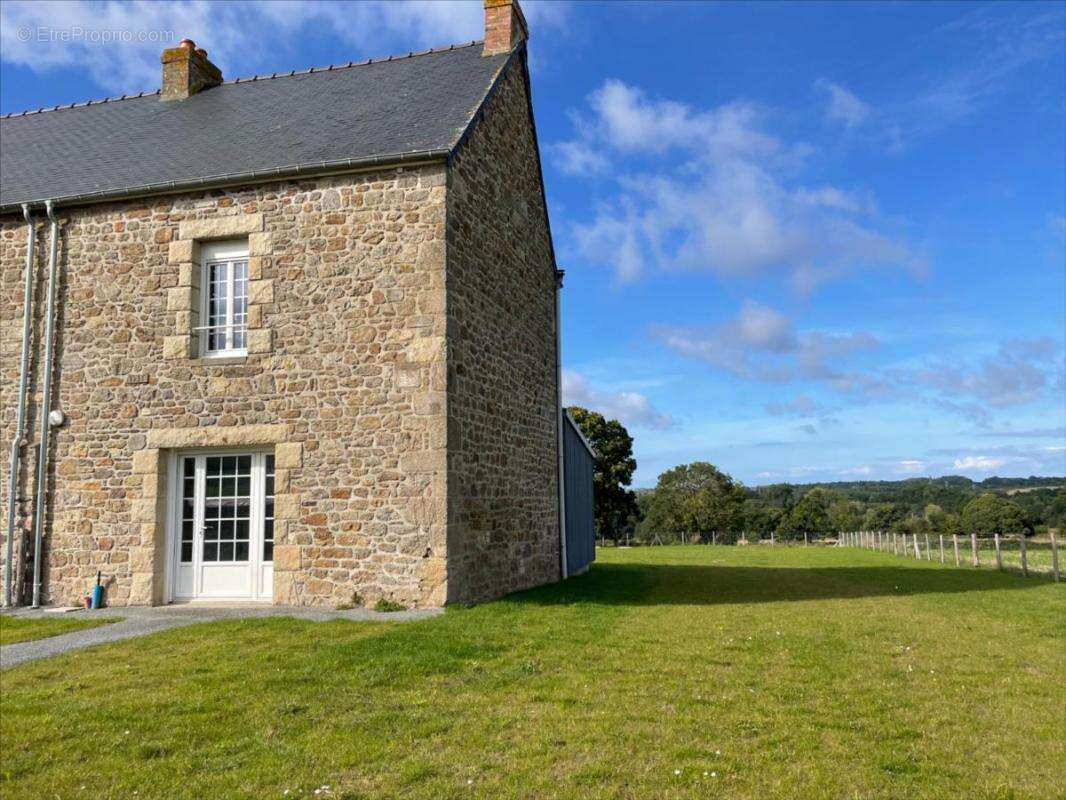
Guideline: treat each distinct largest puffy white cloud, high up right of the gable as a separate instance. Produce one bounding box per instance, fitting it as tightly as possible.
[550,80,924,291]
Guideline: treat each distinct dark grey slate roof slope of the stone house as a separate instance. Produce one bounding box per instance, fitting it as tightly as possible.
[0,43,507,210]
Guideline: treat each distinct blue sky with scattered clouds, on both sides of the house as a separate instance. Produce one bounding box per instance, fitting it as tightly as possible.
[0,0,1066,485]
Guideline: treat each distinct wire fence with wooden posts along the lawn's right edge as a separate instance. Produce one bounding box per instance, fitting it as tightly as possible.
[838,530,1060,582]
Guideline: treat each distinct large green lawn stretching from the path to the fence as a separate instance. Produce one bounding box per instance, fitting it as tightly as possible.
[0,545,1066,800]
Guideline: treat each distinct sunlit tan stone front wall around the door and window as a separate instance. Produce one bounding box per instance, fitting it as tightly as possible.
[0,165,447,605]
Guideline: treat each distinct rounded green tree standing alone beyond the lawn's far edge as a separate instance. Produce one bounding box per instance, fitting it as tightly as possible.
[645,461,745,541]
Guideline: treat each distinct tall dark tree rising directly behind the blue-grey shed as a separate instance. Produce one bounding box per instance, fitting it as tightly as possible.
[567,405,640,541]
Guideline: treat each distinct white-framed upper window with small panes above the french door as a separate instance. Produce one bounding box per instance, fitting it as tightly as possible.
[197,240,248,357]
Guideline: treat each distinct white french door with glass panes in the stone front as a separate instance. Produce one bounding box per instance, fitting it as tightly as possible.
[171,452,274,601]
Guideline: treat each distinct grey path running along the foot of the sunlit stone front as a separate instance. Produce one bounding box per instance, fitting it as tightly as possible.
[0,604,443,669]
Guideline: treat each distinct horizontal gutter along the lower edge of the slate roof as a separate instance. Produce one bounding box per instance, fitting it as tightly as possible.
[0,148,450,213]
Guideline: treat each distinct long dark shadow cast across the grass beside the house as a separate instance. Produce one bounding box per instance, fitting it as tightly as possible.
[507,563,1045,606]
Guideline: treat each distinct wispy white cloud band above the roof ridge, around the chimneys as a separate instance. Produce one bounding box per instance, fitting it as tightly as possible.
[0,0,569,94]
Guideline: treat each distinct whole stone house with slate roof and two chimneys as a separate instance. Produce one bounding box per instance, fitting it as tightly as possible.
[0,0,592,606]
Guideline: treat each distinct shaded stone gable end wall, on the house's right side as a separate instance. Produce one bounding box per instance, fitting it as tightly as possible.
[447,54,560,602]
